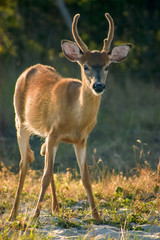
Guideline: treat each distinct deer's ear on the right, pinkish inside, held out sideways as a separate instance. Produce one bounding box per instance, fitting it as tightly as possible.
[108,43,132,63]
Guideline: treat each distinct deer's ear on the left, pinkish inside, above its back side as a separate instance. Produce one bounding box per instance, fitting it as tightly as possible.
[61,40,83,62]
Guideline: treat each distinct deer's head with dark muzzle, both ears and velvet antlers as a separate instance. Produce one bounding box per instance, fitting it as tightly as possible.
[61,13,132,95]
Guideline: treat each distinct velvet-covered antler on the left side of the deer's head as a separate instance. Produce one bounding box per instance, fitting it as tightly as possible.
[72,14,88,52]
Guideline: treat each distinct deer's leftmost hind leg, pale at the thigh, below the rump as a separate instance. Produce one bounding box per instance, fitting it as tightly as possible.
[10,120,34,220]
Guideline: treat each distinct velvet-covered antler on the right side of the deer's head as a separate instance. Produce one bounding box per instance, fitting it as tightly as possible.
[102,13,114,52]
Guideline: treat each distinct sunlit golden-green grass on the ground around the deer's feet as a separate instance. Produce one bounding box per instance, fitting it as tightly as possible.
[0,157,160,239]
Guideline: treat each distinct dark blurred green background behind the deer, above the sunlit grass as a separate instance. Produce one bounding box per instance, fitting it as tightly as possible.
[0,0,160,172]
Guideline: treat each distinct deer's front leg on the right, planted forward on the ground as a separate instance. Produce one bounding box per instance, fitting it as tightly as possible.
[74,140,100,221]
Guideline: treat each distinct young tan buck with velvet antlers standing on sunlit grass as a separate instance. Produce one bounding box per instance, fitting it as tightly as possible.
[10,13,131,220]
